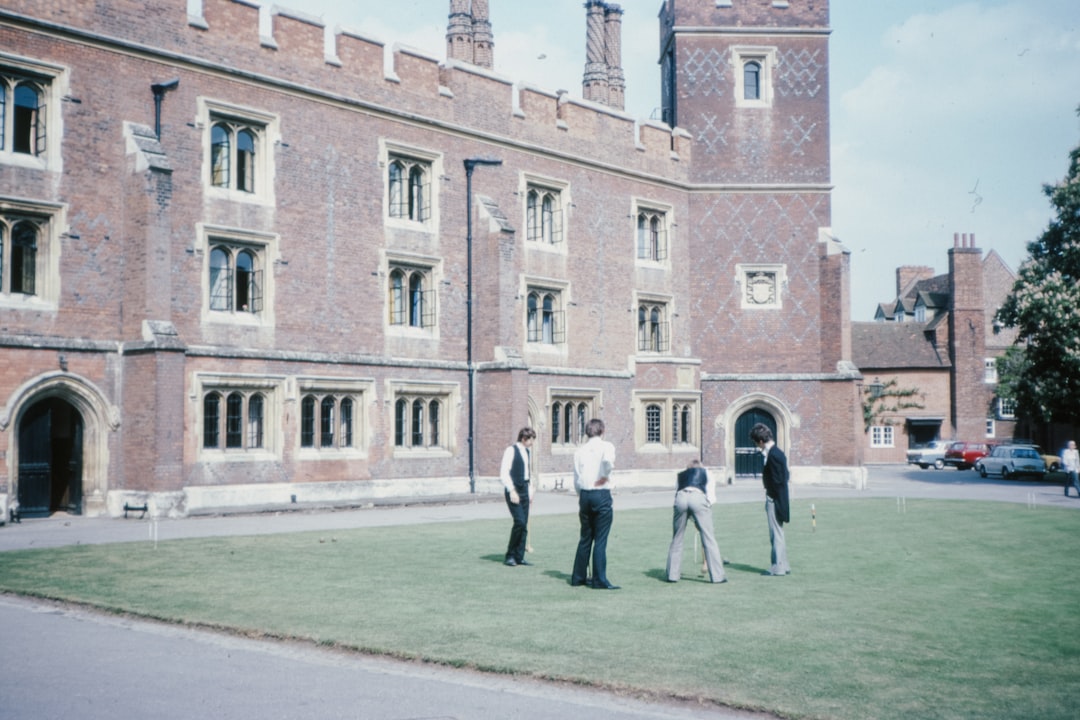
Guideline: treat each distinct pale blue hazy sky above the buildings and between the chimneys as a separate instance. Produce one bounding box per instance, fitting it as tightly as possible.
[261,0,1080,321]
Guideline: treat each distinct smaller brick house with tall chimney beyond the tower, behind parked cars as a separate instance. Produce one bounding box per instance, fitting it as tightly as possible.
[851,233,1016,462]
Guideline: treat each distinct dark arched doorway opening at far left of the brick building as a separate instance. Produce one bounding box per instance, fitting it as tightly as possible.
[17,397,83,517]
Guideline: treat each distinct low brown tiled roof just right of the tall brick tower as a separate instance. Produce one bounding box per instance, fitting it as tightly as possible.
[851,323,949,370]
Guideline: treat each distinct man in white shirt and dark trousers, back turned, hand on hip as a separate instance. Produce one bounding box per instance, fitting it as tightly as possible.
[570,418,619,590]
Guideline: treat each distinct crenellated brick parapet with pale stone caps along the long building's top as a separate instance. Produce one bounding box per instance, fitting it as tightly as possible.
[0,0,689,178]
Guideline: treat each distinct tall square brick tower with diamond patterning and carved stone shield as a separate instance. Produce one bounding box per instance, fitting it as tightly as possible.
[660,0,862,474]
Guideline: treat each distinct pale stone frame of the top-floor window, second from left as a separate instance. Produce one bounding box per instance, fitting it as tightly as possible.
[197,97,281,207]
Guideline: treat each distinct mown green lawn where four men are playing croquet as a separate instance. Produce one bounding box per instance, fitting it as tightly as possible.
[0,500,1080,720]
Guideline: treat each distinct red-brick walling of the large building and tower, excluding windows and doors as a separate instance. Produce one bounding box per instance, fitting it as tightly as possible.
[0,0,856,518]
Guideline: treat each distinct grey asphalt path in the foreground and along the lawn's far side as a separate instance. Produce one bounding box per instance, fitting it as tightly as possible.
[0,466,1080,720]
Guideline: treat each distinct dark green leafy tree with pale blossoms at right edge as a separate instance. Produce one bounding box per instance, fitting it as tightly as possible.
[998,120,1080,423]
